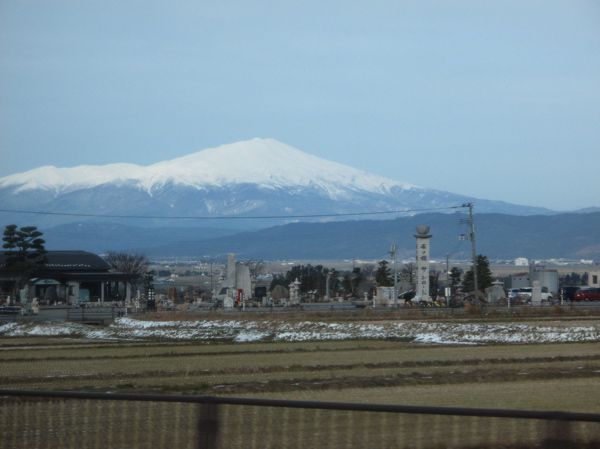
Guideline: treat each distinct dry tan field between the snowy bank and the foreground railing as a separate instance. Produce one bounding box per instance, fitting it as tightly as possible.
[0,337,600,413]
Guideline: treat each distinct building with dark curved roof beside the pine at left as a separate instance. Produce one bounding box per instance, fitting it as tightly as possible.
[0,251,133,305]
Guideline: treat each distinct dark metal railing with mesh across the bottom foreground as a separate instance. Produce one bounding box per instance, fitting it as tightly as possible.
[0,390,600,449]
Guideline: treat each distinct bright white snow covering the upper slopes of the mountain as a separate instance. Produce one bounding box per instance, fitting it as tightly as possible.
[0,139,415,198]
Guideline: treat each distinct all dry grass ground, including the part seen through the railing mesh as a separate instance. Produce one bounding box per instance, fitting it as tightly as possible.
[0,320,600,449]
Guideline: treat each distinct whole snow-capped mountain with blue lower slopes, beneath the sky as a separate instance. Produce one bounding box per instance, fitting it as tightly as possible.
[0,139,549,226]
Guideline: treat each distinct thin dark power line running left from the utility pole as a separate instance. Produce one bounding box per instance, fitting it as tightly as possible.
[0,205,464,220]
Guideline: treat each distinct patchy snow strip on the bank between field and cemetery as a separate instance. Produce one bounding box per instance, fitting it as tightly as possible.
[0,317,600,344]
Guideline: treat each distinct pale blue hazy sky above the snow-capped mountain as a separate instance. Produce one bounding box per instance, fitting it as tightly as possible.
[0,0,600,210]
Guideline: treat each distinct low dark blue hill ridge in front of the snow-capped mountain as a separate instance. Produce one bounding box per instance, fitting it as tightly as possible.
[44,212,600,260]
